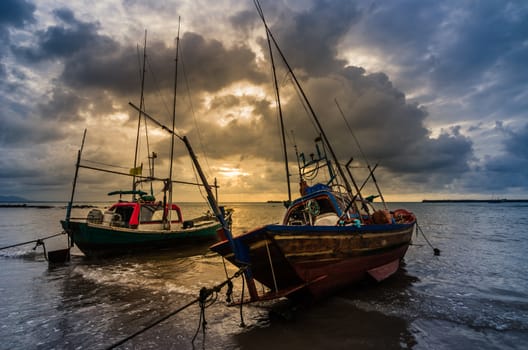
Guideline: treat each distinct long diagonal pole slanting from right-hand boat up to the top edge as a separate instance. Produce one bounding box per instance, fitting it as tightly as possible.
[253,0,353,196]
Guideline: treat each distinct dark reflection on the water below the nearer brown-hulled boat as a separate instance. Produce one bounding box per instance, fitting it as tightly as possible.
[234,273,417,349]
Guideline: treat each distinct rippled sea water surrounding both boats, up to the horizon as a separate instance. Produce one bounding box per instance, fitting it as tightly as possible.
[0,203,528,350]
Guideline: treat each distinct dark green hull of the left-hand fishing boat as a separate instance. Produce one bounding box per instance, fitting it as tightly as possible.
[61,221,220,257]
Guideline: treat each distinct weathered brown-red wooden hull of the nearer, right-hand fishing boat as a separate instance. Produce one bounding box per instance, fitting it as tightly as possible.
[211,223,415,299]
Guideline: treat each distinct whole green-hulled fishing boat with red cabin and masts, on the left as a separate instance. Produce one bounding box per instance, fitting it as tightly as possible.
[61,29,231,257]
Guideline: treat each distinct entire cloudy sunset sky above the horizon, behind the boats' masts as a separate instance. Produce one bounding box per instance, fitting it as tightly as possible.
[0,0,528,202]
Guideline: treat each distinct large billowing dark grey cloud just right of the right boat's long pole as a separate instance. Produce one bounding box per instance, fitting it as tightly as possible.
[334,73,473,182]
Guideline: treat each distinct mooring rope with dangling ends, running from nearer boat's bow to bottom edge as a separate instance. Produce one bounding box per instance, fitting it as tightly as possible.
[106,266,247,349]
